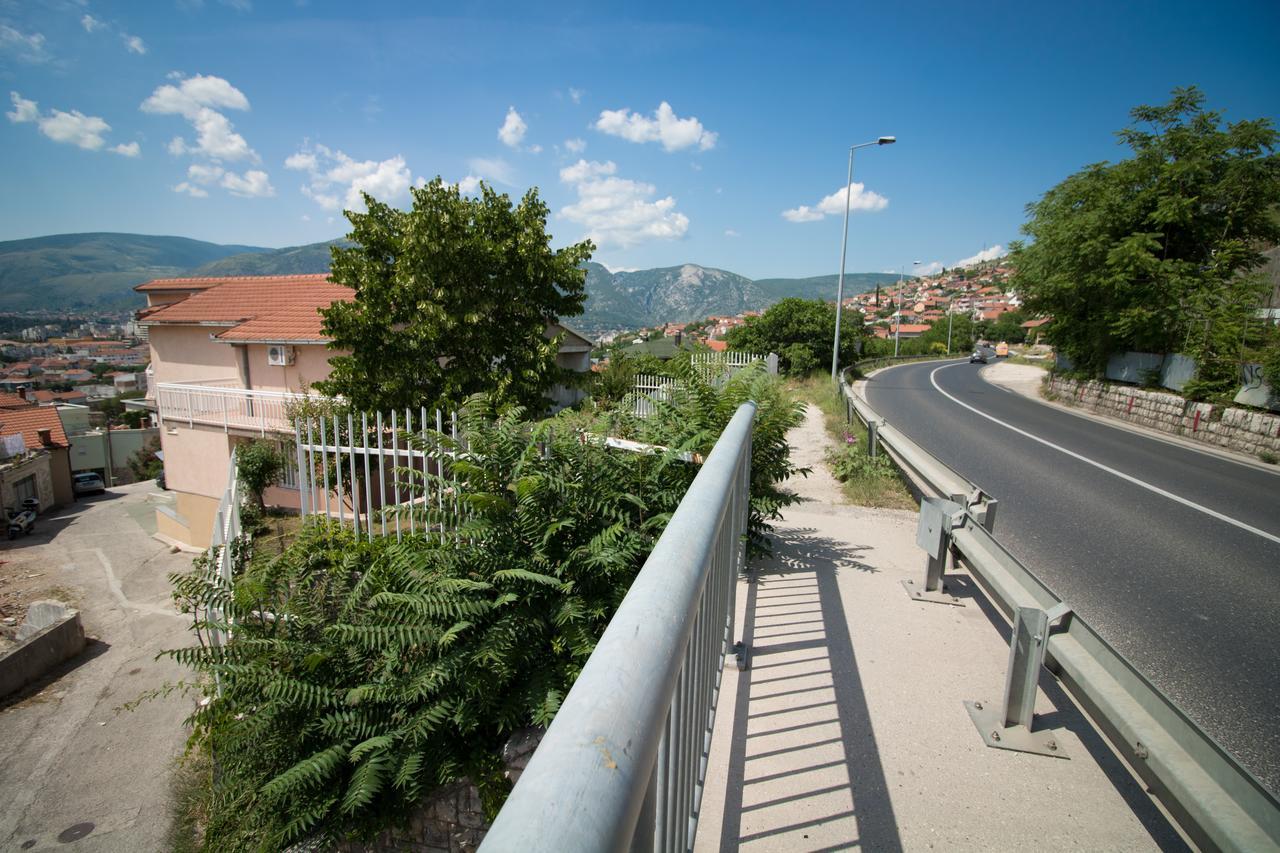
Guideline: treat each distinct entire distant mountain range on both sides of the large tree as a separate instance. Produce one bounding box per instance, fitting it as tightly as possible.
[0,233,896,333]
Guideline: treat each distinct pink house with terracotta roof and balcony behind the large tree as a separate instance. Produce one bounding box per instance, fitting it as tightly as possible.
[137,273,595,547]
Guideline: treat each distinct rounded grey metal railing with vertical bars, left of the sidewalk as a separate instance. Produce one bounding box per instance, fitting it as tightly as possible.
[480,403,755,853]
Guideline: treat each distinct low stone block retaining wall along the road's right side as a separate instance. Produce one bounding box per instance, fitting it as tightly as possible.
[1048,377,1280,456]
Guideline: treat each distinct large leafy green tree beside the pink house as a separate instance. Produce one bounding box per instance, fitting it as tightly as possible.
[317,178,594,411]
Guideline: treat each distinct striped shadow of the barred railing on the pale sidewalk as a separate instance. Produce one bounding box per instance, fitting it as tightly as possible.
[719,529,902,852]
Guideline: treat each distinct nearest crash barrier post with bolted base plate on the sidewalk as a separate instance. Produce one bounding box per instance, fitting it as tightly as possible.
[964,603,1071,758]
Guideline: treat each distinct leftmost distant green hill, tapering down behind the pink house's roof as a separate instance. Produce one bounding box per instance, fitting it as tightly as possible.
[0,233,270,311]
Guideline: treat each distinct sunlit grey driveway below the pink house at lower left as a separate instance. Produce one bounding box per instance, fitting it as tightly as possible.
[0,482,192,850]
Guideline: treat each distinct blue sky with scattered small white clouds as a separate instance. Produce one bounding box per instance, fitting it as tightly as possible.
[0,0,1280,278]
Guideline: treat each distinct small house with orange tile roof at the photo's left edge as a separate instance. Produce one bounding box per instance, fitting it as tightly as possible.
[0,405,76,511]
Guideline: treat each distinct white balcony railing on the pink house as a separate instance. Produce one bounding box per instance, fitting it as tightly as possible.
[156,379,317,435]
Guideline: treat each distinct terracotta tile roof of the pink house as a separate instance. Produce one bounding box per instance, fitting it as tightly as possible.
[143,274,355,341]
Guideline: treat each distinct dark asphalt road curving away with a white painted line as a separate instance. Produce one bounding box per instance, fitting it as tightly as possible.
[867,361,1280,793]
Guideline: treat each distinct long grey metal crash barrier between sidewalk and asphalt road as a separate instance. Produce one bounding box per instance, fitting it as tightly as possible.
[842,361,1280,852]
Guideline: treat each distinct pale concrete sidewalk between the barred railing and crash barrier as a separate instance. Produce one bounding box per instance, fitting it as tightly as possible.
[695,407,1185,850]
